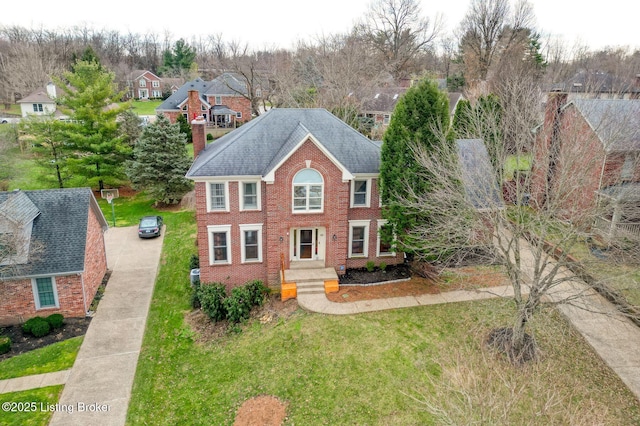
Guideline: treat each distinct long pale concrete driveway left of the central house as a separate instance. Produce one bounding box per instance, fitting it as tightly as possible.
[49,227,163,426]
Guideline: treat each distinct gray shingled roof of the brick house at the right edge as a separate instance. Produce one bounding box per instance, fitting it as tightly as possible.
[569,99,640,152]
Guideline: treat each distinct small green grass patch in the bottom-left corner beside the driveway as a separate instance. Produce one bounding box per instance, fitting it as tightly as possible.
[0,386,64,426]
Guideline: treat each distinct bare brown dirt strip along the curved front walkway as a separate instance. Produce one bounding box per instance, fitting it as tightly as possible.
[327,266,509,303]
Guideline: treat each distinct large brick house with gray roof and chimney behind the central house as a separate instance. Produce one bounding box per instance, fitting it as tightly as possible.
[156,73,262,128]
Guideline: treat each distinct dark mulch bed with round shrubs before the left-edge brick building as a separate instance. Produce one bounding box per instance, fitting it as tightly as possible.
[0,318,91,361]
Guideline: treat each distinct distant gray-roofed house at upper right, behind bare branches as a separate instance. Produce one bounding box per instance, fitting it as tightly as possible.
[550,70,640,100]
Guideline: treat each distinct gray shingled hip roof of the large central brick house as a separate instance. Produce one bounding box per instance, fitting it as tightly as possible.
[187,108,380,178]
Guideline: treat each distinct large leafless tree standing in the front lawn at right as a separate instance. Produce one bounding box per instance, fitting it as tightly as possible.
[396,87,640,362]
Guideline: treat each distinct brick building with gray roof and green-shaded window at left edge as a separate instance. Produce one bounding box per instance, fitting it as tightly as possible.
[0,188,108,324]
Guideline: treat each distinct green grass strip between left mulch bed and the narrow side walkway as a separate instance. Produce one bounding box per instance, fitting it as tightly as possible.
[0,336,83,380]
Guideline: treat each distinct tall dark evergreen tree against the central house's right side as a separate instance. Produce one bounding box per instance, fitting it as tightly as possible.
[380,80,449,252]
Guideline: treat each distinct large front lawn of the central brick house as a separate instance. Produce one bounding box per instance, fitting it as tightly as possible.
[127,213,640,425]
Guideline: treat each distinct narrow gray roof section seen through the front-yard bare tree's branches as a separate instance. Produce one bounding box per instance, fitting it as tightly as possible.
[456,139,504,211]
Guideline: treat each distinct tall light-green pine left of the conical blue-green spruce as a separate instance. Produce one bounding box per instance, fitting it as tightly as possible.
[56,61,131,189]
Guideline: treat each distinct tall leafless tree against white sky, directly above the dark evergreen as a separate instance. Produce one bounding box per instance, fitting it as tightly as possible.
[356,0,442,81]
